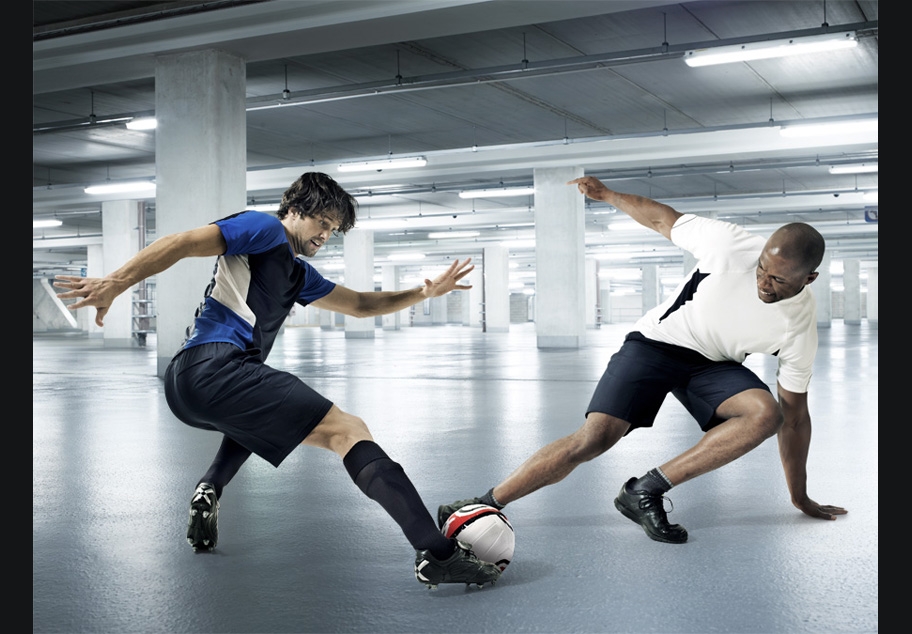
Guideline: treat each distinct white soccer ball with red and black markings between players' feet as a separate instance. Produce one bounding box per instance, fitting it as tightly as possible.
[441,504,516,572]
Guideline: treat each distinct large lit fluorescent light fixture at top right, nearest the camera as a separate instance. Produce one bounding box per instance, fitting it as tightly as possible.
[684,31,858,66]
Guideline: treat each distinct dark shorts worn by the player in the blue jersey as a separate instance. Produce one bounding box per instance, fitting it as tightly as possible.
[165,343,332,467]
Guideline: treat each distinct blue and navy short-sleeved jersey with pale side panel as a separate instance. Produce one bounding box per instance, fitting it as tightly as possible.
[181,211,336,359]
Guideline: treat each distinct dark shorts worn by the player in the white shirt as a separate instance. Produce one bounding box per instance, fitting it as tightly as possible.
[586,332,770,433]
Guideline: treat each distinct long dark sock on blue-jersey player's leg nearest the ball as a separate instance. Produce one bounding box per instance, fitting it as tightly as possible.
[342,440,456,559]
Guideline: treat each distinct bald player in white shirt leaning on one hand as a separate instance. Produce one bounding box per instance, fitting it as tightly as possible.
[437,176,846,544]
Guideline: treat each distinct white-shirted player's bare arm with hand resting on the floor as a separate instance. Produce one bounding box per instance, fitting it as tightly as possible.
[779,385,848,520]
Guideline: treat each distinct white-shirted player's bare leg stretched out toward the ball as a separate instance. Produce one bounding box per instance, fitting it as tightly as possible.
[494,412,630,505]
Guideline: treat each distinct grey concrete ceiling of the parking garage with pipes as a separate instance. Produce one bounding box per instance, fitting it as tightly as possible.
[32,0,878,283]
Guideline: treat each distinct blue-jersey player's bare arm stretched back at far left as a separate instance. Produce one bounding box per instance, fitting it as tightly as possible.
[54,225,227,326]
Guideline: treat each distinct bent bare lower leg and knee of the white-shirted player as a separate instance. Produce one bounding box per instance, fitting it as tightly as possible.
[660,389,782,485]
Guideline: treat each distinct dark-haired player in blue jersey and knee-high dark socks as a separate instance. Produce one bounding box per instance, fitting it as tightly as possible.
[55,172,500,587]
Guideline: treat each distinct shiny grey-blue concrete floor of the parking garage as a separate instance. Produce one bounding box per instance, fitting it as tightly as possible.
[32,321,878,633]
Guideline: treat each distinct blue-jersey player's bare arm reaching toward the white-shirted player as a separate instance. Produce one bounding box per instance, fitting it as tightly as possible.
[313,258,475,317]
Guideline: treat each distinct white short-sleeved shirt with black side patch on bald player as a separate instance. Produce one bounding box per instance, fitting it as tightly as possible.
[635,214,817,393]
